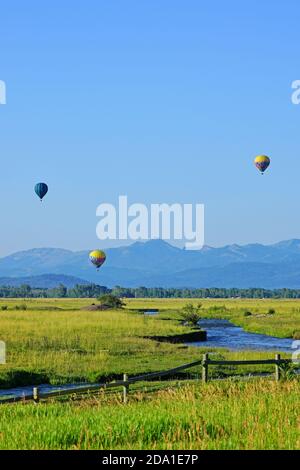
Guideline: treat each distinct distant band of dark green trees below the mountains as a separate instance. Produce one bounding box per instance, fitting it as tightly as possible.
[0,284,300,299]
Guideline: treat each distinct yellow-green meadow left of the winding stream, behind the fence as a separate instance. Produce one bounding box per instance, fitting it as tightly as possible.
[0,302,195,385]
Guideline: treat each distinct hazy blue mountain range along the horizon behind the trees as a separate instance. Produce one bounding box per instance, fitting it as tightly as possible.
[0,240,300,289]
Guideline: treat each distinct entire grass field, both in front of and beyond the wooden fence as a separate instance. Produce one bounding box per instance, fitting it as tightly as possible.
[0,299,300,450]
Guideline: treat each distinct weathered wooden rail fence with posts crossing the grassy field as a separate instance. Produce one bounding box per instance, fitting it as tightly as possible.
[0,354,300,404]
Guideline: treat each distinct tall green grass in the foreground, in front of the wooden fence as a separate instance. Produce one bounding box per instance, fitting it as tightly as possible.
[0,379,300,450]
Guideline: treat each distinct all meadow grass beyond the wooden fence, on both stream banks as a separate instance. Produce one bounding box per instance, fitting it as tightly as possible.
[0,299,300,388]
